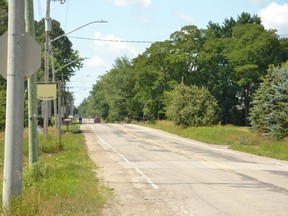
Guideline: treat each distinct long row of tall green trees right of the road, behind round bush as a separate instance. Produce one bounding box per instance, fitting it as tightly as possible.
[79,13,288,125]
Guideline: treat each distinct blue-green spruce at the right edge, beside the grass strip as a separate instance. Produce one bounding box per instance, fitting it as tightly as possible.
[250,63,288,139]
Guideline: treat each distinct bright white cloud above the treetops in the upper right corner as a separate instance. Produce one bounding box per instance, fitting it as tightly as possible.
[259,2,288,35]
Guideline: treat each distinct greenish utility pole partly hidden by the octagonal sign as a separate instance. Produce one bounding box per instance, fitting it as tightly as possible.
[25,0,38,166]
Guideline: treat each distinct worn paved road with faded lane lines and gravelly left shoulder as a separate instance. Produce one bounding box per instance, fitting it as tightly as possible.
[82,124,288,216]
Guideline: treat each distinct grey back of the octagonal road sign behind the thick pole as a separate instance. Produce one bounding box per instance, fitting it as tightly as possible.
[0,32,41,79]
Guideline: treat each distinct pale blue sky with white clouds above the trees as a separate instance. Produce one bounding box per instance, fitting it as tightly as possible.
[34,0,288,106]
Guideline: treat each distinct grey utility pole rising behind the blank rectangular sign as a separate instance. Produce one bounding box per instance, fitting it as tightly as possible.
[43,0,51,138]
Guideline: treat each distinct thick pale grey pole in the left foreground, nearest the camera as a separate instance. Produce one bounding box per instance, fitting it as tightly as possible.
[3,0,25,210]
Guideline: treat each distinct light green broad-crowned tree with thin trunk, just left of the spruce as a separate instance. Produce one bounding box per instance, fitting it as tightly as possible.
[225,23,281,125]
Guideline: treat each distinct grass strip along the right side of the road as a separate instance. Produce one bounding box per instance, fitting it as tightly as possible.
[142,121,288,161]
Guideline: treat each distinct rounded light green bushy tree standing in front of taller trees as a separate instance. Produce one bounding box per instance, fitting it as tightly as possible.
[166,85,218,127]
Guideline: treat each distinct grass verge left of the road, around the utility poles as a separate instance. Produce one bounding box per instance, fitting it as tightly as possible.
[0,125,112,216]
